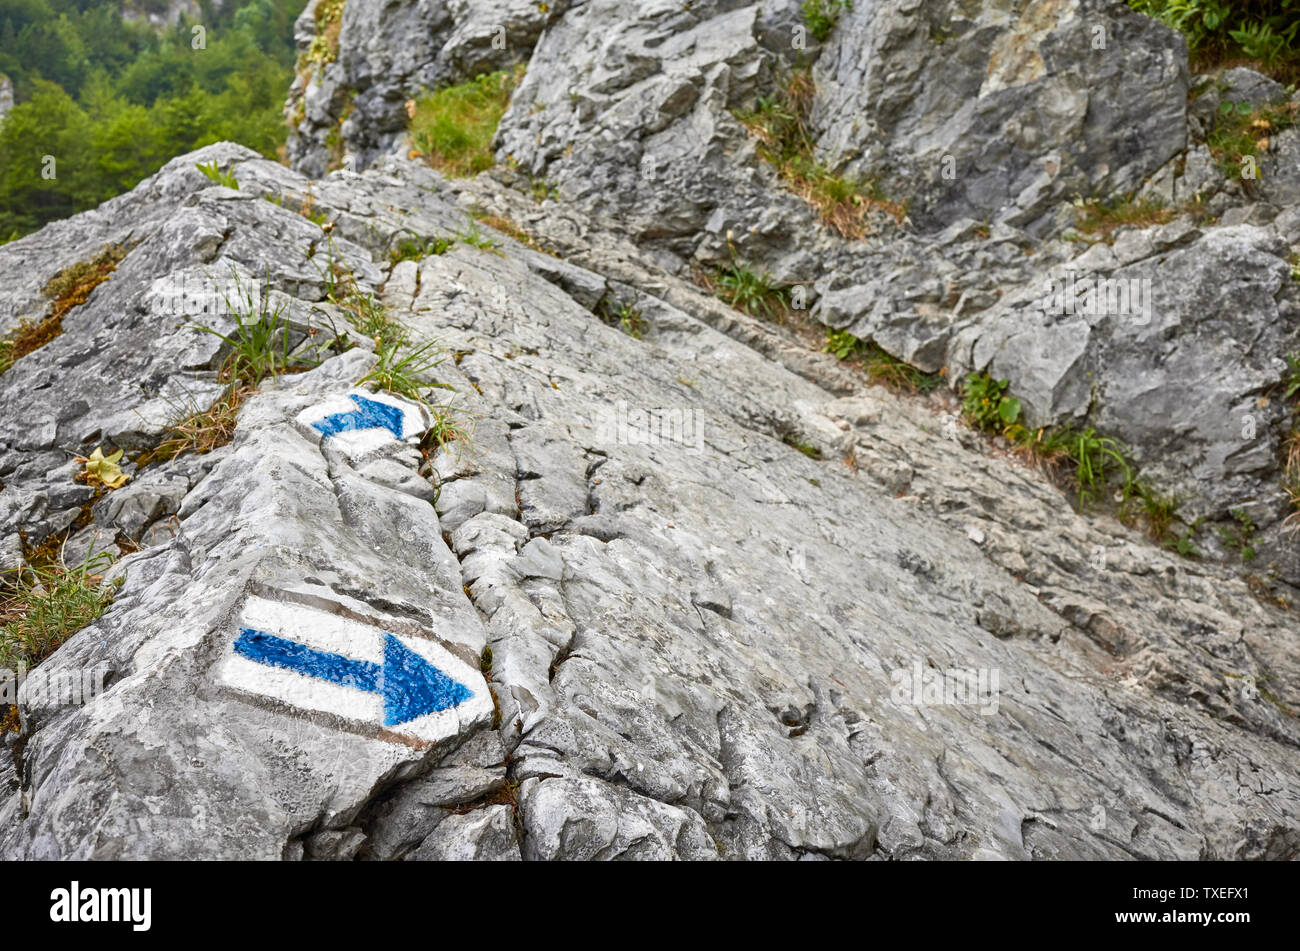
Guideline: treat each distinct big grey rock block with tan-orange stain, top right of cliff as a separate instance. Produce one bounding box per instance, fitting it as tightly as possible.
[813,0,1187,234]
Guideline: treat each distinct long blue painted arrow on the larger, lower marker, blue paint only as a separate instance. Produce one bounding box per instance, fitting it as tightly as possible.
[235,628,473,726]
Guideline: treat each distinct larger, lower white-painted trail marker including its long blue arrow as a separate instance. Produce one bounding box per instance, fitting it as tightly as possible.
[217,595,493,744]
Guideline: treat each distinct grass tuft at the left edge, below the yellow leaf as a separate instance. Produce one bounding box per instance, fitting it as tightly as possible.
[0,551,116,670]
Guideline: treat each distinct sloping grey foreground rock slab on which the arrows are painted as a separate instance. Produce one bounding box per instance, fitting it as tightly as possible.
[0,146,1300,859]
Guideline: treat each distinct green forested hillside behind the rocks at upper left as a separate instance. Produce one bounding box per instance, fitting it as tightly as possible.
[0,0,306,243]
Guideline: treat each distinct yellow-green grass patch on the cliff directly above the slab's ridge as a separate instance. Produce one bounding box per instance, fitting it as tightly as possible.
[410,66,523,178]
